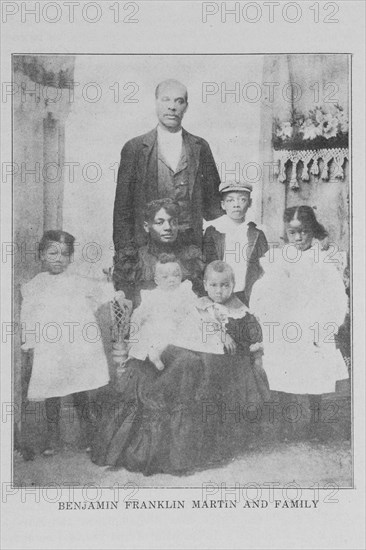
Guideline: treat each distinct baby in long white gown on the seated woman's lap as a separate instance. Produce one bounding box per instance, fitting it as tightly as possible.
[129,253,223,370]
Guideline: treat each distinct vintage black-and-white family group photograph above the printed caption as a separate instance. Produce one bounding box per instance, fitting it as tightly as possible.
[12,53,354,488]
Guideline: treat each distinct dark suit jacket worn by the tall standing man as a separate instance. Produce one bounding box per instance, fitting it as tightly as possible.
[113,128,220,250]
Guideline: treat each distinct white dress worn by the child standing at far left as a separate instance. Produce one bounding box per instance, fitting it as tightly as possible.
[21,271,115,401]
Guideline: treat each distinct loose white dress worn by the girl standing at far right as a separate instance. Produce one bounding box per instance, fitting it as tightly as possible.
[250,243,348,394]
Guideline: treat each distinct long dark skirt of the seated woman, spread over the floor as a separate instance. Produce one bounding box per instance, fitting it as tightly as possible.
[92,346,269,475]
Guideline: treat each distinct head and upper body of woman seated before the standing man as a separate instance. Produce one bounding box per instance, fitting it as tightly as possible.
[114,198,204,306]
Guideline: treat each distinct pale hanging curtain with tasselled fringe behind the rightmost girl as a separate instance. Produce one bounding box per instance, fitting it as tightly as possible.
[260,54,350,252]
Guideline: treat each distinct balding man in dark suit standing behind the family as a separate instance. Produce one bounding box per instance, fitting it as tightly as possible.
[113,80,220,256]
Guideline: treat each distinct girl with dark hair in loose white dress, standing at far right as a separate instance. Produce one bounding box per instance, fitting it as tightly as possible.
[251,206,348,442]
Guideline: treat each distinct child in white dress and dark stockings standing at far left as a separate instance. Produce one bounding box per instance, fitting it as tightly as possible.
[21,230,120,456]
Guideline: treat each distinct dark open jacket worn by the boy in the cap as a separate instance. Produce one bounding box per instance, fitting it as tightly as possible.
[203,222,268,306]
